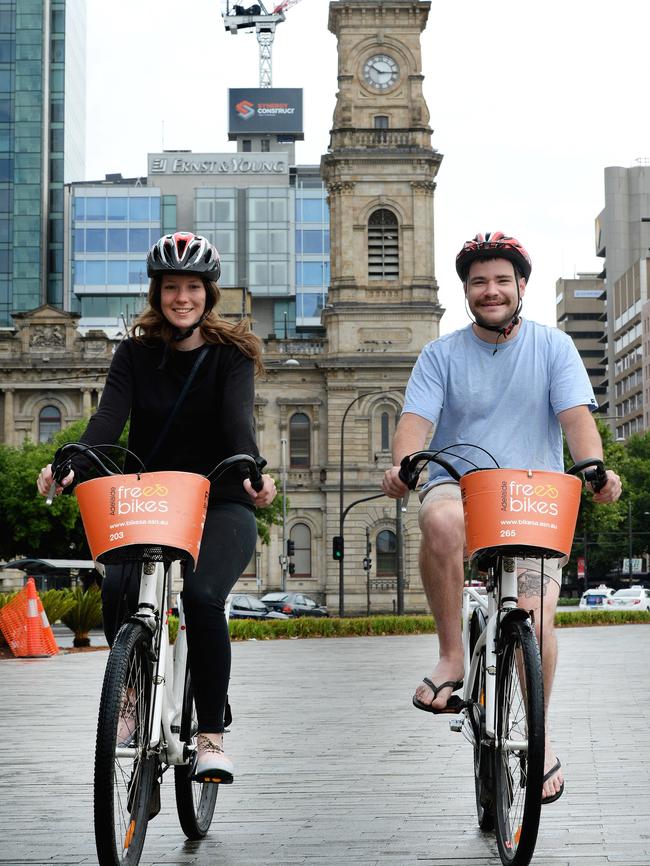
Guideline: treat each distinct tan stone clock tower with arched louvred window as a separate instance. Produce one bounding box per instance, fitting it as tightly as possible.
[321,0,443,354]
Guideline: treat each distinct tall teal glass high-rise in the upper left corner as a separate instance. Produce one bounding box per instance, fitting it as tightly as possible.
[0,0,86,327]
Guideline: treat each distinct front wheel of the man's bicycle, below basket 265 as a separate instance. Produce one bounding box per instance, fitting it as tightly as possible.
[494,619,544,866]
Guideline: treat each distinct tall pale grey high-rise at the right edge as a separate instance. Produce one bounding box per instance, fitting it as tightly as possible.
[596,160,650,438]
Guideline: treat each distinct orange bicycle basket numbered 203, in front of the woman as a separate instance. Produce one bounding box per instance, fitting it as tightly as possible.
[75,472,210,565]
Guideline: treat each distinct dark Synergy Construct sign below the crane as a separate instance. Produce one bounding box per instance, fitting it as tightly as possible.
[228,87,303,140]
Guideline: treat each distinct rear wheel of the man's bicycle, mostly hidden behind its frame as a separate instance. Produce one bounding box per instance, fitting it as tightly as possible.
[469,610,494,830]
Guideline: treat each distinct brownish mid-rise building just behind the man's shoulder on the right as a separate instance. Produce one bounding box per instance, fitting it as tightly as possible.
[555,274,607,406]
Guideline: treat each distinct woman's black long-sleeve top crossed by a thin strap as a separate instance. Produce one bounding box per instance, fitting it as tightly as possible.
[74,339,259,506]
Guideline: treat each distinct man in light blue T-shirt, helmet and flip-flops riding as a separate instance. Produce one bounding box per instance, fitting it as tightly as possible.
[383,232,621,803]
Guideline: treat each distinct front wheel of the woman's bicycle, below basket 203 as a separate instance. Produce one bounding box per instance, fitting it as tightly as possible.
[94,622,158,866]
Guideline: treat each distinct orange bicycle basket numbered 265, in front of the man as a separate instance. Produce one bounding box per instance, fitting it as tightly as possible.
[460,469,582,559]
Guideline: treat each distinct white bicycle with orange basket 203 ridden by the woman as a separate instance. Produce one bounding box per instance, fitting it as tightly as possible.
[50,443,262,866]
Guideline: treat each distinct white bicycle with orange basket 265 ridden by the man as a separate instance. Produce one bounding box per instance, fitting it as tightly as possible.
[400,446,607,866]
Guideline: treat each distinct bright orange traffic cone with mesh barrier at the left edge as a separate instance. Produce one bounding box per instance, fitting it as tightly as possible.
[0,577,59,658]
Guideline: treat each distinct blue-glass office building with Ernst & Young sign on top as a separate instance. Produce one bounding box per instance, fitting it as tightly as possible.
[66,151,329,338]
